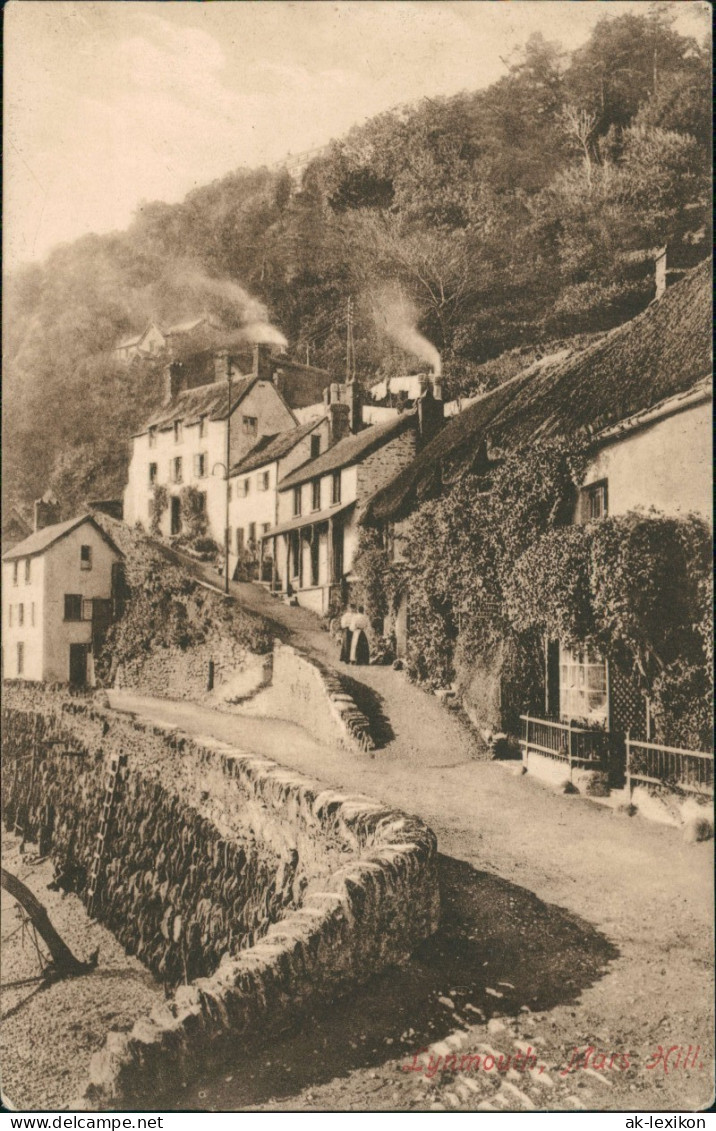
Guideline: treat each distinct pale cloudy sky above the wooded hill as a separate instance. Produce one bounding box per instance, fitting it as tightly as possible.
[3,0,710,268]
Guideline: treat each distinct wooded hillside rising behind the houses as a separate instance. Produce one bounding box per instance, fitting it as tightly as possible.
[3,11,711,515]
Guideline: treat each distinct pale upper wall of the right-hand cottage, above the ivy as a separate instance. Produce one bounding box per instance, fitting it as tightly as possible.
[575,402,713,521]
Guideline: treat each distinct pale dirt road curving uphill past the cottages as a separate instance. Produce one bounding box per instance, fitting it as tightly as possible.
[112,687,713,1111]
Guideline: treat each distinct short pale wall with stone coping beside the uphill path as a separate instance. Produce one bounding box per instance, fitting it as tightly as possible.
[273,641,374,751]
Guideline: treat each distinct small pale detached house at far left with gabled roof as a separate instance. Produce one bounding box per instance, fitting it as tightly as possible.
[2,515,122,685]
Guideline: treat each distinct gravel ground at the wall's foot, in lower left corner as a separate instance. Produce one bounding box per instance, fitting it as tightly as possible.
[0,834,164,1112]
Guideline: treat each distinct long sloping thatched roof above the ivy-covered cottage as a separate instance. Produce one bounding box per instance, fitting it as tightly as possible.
[362,259,711,523]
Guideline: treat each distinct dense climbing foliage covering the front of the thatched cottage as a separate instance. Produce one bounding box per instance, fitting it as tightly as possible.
[354,440,713,749]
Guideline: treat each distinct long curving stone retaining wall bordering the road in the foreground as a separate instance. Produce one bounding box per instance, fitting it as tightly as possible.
[3,684,439,1110]
